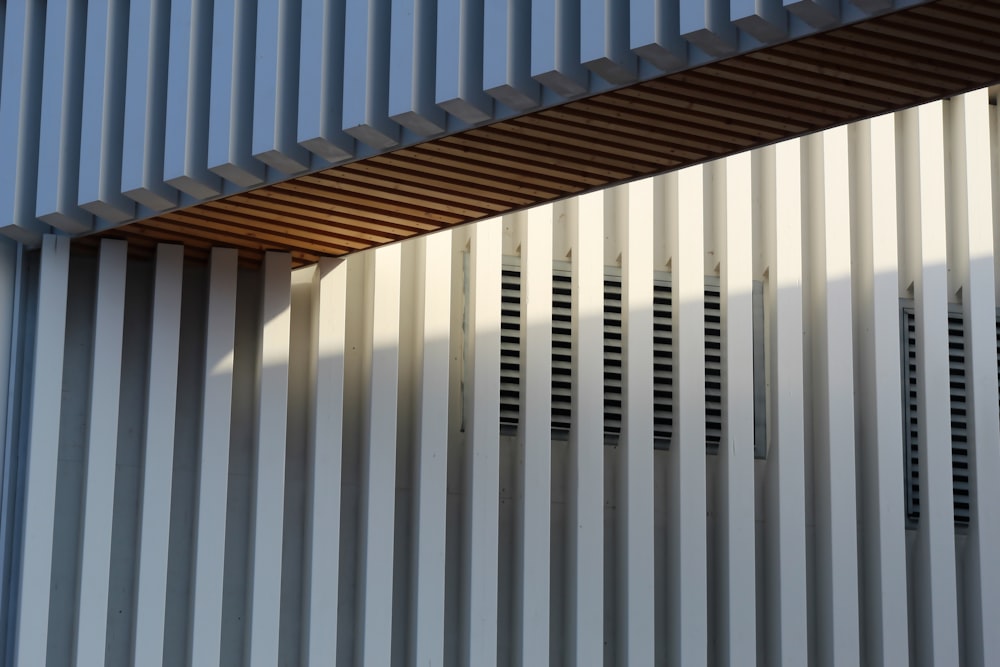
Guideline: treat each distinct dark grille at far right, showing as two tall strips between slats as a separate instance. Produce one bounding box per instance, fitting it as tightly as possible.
[902,306,968,525]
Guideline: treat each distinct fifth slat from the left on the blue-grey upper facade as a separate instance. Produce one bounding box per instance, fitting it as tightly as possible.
[161,2,222,199]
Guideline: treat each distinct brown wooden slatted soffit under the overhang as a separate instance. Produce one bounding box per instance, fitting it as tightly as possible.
[91,0,1000,264]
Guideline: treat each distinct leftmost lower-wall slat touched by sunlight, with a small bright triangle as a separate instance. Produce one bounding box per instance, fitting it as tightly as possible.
[188,248,238,667]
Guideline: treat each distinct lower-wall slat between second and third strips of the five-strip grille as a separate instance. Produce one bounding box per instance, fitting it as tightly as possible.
[566,191,605,665]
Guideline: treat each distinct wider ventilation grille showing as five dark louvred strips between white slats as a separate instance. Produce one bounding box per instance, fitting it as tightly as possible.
[500,266,724,453]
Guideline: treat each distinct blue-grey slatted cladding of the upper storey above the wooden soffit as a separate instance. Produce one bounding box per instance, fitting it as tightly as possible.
[0,0,926,244]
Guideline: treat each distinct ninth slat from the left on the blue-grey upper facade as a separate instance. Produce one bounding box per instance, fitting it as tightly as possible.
[341,0,399,151]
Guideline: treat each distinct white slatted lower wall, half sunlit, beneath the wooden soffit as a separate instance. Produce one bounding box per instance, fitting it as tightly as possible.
[5,91,1000,665]
